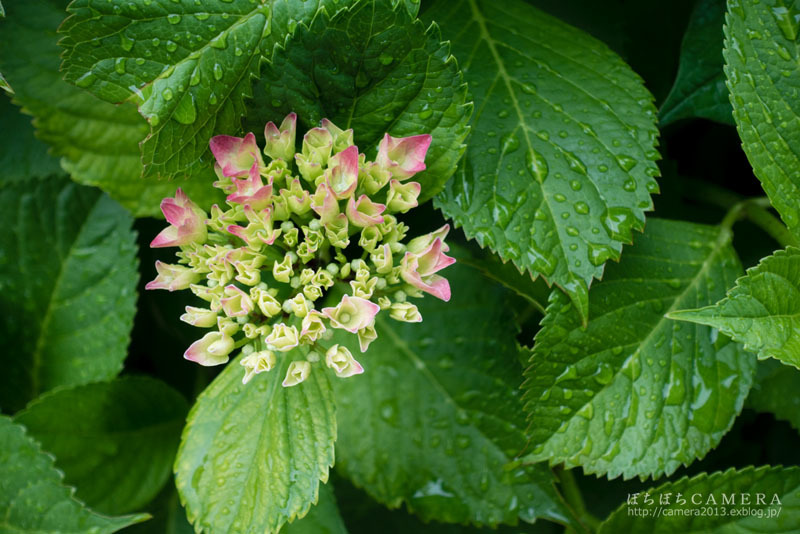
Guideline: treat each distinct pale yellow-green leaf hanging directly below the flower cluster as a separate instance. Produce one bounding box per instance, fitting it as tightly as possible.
[175,357,336,534]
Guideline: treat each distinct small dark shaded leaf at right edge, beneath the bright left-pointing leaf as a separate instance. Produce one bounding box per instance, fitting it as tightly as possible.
[745,360,800,431]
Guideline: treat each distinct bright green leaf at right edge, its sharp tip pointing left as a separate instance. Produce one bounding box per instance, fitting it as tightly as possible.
[671,247,800,368]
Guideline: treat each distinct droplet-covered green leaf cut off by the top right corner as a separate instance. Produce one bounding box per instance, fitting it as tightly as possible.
[723,0,800,237]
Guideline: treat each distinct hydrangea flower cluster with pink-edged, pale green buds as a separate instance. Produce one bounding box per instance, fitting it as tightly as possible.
[146,113,455,386]
